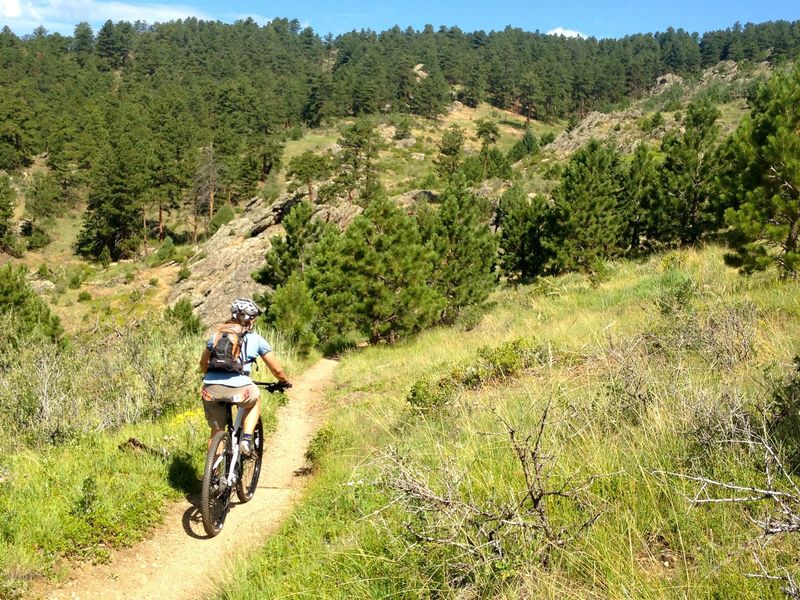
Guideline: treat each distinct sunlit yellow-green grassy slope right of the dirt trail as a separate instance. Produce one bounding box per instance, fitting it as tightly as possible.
[212,248,800,598]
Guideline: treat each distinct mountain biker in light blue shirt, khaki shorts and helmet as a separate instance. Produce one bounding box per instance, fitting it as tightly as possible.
[200,298,291,456]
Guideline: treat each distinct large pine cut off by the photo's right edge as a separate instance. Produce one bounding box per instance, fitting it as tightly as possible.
[725,65,800,276]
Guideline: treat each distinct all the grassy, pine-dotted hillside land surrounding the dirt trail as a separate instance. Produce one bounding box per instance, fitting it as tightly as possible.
[0,14,800,598]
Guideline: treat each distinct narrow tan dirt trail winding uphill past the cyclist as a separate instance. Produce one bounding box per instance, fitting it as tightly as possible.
[36,360,336,600]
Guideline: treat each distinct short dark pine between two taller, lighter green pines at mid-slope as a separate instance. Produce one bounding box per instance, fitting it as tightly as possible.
[497,186,555,281]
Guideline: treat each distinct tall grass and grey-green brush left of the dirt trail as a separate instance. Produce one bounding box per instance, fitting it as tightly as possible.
[0,319,302,598]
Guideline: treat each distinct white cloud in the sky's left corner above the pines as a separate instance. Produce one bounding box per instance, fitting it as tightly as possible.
[0,0,212,34]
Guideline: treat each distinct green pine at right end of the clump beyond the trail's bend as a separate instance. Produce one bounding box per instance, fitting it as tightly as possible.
[420,178,497,323]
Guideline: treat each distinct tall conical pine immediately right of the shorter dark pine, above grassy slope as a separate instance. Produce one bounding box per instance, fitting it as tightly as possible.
[554,140,625,271]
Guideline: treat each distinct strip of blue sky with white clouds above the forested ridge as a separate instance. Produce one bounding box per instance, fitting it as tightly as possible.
[0,0,800,38]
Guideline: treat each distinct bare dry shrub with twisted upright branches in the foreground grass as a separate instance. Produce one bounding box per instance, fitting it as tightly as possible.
[379,406,599,588]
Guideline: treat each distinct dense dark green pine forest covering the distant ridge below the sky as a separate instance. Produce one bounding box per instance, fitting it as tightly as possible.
[0,19,800,259]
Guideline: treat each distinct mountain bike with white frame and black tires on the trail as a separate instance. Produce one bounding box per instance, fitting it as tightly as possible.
[200,381,291,537]
